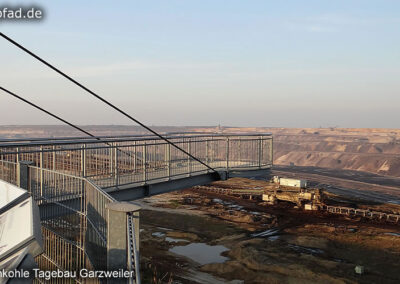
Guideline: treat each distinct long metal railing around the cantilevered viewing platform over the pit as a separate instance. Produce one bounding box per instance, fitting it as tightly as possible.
[0,134,272,188]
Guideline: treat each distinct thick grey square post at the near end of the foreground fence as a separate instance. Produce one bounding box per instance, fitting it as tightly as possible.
[106,202,141,284]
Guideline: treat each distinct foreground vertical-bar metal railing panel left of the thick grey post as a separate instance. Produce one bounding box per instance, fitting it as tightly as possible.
[29,166,115,269]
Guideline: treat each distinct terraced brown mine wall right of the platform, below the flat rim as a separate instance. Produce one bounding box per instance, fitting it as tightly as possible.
[274,140,400,177]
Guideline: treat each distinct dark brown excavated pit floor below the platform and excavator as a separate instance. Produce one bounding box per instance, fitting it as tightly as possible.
[141,176,400,283]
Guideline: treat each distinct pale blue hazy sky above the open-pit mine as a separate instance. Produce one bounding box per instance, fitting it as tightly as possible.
[0,0,400,128]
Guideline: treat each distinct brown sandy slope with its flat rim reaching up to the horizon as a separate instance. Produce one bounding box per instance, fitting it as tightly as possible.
[199,128,400,177]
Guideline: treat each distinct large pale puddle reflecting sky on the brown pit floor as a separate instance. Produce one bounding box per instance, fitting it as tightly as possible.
[169,243,229,265]
